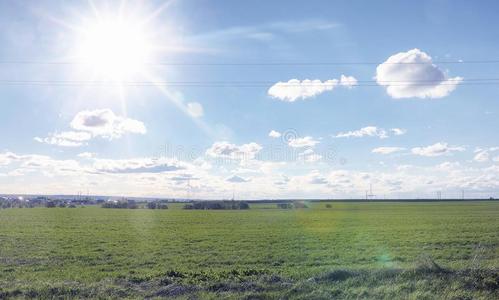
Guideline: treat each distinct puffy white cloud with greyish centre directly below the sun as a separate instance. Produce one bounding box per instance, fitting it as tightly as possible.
[71,109,147,139]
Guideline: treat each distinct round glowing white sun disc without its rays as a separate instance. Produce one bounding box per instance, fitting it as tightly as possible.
[76,16,153,81]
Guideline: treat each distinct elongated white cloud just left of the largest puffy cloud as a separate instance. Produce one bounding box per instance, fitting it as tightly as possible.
[267,75,357,102]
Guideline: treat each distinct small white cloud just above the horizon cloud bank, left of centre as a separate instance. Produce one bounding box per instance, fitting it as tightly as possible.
[206,142,262,160]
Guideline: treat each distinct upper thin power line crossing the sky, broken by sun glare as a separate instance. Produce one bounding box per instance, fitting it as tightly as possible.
[0,59,499,66]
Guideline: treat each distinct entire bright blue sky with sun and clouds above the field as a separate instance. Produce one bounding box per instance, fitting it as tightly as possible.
[0,1,499,199]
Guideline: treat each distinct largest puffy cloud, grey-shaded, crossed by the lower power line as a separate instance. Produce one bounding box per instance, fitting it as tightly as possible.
[376,49,463,99]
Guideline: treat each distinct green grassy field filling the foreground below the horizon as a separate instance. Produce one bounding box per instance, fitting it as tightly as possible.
[0,201,499,299]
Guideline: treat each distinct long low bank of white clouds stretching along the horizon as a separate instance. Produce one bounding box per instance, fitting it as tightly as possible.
[0,147,499,199]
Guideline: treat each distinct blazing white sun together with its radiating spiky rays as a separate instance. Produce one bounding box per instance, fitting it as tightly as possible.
[28,0,216,138]
